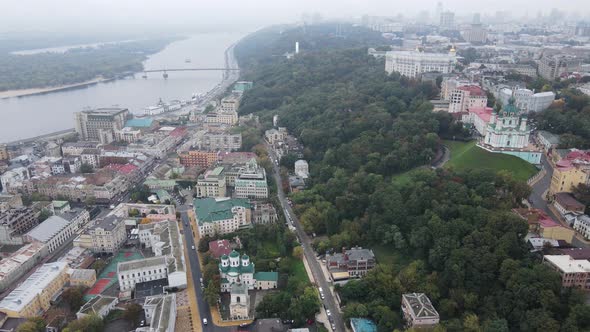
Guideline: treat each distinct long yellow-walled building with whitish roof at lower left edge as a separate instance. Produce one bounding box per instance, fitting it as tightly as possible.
[0,262,68,318]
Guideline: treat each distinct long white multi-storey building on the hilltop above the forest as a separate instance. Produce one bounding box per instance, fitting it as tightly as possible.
[385,49,457,78]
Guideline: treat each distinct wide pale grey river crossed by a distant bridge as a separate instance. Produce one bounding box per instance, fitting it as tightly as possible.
[0,33,242,142]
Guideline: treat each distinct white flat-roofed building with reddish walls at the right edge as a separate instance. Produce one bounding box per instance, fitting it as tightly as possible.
[543,255,590,290]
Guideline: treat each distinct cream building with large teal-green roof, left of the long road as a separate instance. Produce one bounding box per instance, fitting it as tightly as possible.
[194,197,252,236]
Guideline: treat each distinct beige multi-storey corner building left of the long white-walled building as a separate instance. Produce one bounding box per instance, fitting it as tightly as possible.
[87,215,127,252]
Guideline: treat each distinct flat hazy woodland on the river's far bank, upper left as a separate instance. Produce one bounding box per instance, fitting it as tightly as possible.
[0,38,173,91]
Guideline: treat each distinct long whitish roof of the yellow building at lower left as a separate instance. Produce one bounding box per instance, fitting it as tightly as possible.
[0,262,68,311]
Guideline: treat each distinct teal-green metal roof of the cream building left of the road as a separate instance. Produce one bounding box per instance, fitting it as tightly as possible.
[194,197,250,224]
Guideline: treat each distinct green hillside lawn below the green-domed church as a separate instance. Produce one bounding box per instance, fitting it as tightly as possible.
[444,141,537,181]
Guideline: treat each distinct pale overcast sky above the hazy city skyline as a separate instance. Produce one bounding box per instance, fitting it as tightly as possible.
[0,0,590,32]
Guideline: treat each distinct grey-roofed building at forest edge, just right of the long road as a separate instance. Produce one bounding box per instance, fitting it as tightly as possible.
[326,247,375,278]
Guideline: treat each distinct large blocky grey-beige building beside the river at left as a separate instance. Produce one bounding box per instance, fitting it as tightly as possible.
[74,107,129,143]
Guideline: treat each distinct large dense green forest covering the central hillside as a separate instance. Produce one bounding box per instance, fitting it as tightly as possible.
[236,25,590,332]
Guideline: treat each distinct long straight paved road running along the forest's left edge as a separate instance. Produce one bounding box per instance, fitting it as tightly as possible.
[266,144,345,331]
